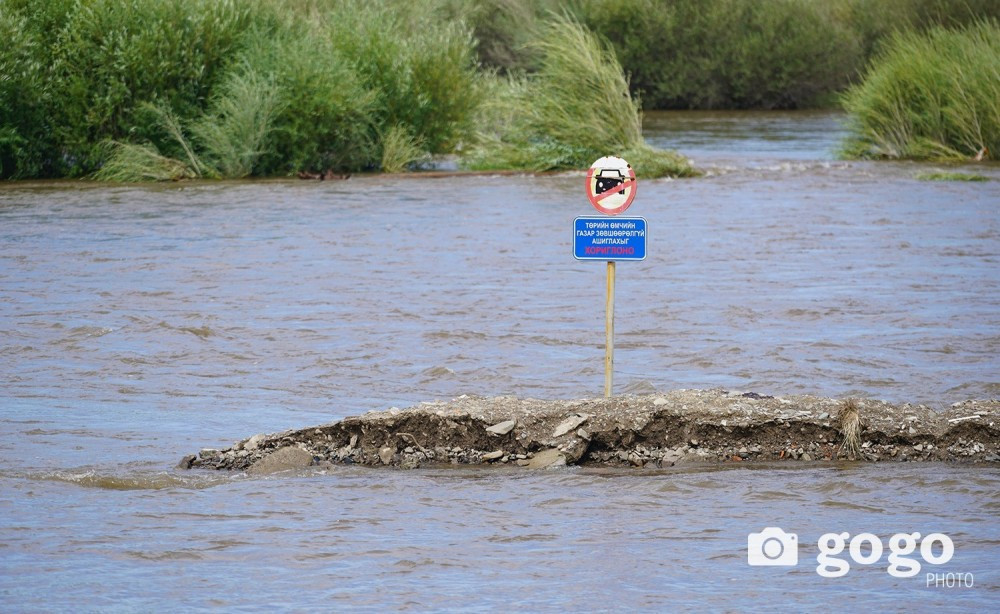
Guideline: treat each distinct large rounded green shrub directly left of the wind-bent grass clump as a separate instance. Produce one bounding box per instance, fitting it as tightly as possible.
[244,0,483,174]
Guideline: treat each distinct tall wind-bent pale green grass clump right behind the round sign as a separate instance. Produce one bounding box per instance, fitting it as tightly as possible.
[466,16,693,177]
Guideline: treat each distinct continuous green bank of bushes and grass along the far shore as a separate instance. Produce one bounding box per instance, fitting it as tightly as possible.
[0,0,1000,181]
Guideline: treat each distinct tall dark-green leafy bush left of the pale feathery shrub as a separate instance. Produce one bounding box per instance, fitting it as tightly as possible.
[52,0,250,174]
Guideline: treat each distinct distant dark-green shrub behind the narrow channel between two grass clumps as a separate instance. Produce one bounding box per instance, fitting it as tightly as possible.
[580,0,862,109]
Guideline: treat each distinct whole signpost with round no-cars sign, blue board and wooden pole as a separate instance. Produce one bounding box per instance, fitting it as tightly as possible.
[573,156,646,398]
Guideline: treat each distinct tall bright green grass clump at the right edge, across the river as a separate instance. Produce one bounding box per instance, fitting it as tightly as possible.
[843,21,1000,159]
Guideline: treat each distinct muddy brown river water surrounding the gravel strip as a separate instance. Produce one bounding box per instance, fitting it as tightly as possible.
[0,113,1000,611]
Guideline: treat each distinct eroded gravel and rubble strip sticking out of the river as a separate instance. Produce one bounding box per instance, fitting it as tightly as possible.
[179,390,1000,474]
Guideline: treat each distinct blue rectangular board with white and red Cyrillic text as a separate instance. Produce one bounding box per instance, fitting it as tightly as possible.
[573,216,646,260]
